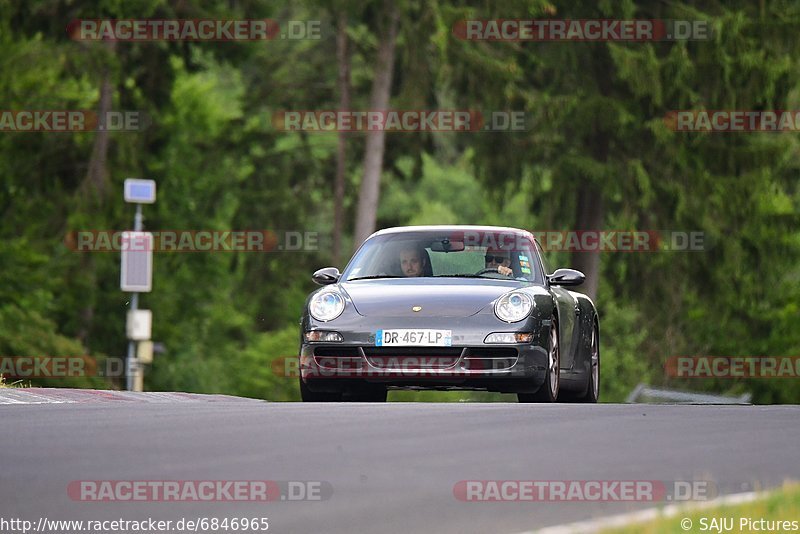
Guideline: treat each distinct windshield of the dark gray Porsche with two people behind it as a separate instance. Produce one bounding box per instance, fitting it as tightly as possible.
[342,230,543,283]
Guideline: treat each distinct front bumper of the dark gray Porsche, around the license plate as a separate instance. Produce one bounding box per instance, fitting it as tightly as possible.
[299,306,550,393]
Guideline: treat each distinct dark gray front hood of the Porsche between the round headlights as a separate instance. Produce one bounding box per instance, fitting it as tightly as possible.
[341,279,527,317]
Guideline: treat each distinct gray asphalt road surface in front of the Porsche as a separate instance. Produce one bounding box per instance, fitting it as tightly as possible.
[0,394,800,533]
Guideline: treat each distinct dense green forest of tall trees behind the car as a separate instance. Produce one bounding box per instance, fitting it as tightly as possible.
[0,0,800,403]
